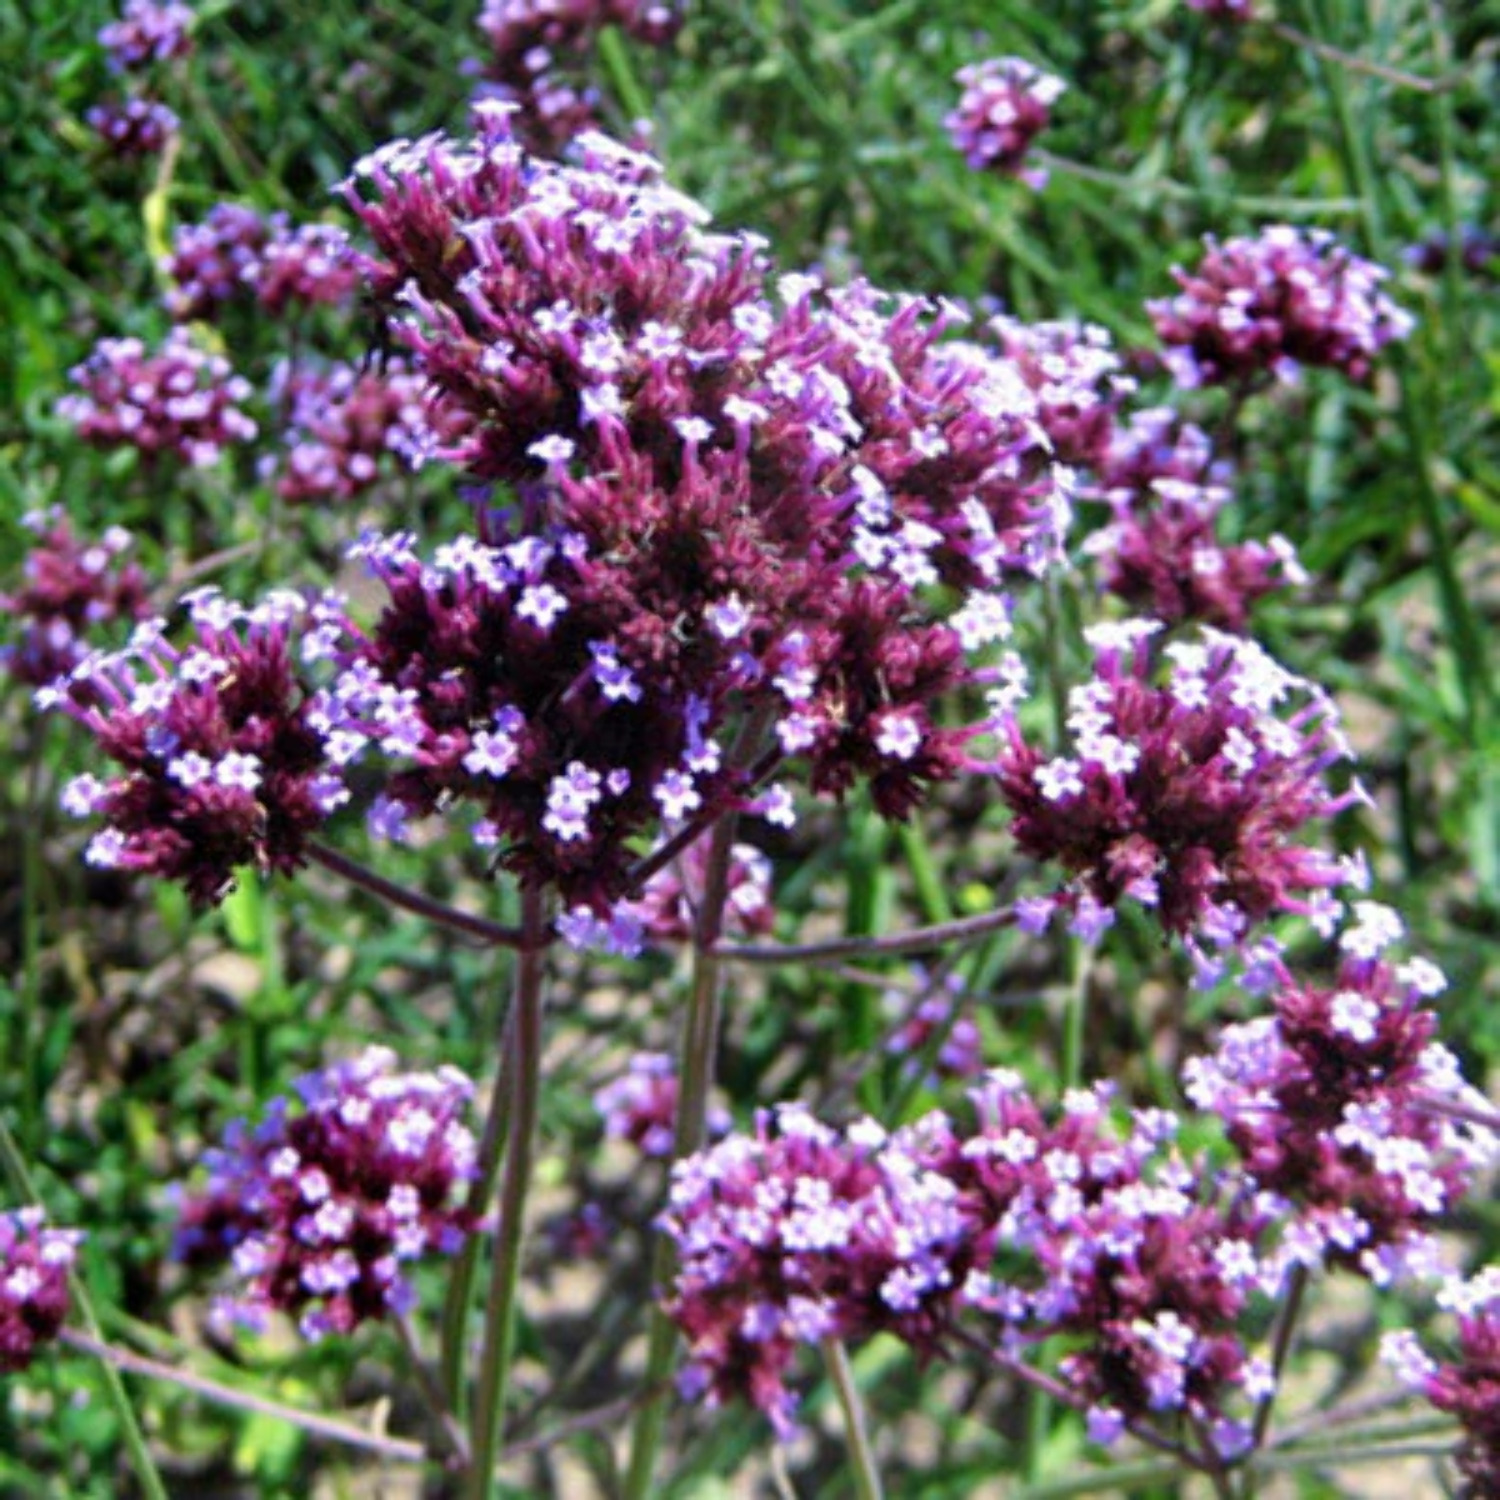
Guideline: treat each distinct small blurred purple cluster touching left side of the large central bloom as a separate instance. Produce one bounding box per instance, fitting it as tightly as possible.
[263,365,432,506]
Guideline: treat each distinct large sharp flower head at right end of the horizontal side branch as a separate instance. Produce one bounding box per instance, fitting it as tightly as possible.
[998,621,1362,948]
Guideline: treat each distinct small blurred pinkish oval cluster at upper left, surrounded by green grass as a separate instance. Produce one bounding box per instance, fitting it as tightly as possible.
[57,329,258,468]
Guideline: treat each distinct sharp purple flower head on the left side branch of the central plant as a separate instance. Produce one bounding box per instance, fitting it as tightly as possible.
[38,590,348,905]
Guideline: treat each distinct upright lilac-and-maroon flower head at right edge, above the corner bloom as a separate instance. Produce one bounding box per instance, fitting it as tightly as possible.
[1185,902,1500,1284]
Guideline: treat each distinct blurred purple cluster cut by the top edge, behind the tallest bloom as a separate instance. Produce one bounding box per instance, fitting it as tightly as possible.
[479,0,683,155]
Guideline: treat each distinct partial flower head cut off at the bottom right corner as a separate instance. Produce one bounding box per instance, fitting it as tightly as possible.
[1382,1266,1500,1500]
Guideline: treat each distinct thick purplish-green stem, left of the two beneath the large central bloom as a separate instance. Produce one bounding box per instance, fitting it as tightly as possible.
[465,890,548,1500]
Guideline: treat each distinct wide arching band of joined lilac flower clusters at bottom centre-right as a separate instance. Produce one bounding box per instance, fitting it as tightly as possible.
[663,1073,1280,1457]
